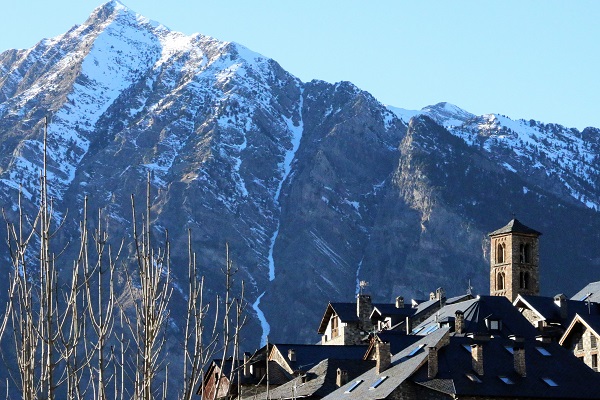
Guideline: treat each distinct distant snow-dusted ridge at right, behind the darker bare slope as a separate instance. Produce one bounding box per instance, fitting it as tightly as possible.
[389,103,600,211]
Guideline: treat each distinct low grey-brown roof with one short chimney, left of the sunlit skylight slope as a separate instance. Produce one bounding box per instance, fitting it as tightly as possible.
[245,359,375,400]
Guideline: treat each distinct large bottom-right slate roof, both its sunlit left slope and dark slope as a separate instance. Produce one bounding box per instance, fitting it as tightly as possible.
[325,328,600,400]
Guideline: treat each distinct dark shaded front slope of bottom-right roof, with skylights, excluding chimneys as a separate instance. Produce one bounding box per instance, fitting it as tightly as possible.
[411,336,600,399]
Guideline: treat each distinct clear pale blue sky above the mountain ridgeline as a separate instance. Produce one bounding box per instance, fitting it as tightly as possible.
[0,0,600,129]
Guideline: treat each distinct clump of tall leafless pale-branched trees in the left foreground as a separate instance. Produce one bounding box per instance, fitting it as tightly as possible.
[0,115,251,400]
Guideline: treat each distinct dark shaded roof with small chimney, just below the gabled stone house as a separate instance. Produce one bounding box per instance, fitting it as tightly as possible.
[273,344,368,371]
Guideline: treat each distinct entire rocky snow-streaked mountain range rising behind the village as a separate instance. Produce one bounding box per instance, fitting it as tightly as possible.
[0,1,600,349]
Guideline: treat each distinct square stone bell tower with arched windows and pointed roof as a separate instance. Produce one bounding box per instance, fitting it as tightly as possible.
[489,219,541,302]
